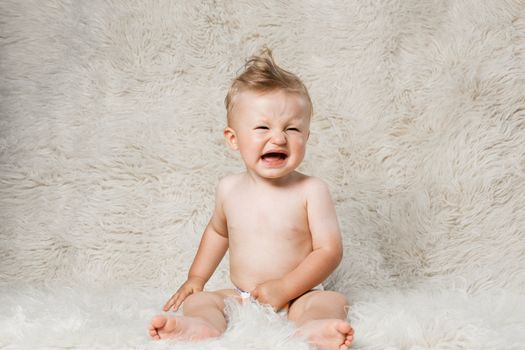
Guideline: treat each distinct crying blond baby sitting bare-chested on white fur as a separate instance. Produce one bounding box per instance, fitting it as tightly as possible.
[149,49,354,350]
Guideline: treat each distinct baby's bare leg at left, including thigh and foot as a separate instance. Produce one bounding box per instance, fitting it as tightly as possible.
[149,290,235,340]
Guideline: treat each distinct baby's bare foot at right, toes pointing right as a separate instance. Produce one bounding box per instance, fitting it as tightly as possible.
[296,319,354,350]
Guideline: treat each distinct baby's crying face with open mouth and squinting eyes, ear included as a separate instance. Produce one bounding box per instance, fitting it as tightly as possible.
[224,90,310,179]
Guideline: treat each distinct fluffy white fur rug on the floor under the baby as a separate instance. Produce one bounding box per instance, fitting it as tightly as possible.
[0,284,525,350]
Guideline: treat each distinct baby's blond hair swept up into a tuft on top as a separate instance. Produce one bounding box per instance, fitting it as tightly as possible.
[224,47,313,124]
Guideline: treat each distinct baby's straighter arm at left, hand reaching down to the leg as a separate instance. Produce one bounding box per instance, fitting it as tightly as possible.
[163,181,228,311]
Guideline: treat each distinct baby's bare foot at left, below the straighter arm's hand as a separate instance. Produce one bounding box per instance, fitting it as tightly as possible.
[149,315,220,340]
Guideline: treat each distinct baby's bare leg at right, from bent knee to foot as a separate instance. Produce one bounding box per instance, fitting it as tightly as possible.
[288,291,354,350]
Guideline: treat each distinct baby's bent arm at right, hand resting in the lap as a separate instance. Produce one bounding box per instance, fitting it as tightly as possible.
[254,178,343,308]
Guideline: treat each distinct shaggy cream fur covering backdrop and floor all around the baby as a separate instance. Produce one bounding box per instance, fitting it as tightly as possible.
[0,0,525,350]
